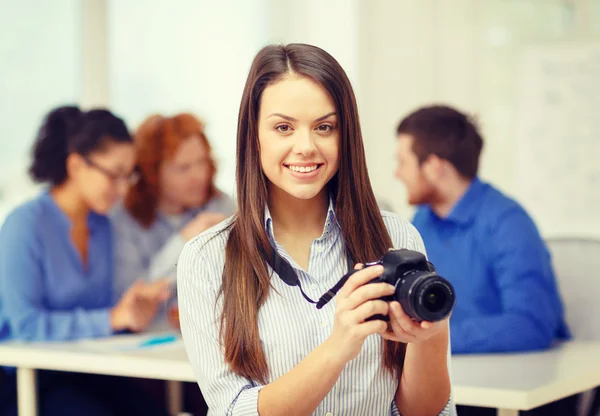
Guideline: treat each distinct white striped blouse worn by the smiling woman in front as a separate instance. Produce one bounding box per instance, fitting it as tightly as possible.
[177,201,456,416]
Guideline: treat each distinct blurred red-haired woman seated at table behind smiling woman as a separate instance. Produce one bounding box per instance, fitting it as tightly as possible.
[111,113,234,295]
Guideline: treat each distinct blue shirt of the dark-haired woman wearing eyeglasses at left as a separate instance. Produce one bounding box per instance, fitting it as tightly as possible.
[0,192,113,341]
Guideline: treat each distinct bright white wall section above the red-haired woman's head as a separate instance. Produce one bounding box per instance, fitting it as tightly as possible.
[108,0,269,197]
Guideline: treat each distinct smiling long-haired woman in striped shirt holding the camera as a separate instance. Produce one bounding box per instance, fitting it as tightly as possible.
[177,44,454,415]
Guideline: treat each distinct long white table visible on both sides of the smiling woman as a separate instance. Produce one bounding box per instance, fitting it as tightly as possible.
[0,335,600,416]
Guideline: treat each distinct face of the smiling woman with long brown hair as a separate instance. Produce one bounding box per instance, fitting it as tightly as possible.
[258,74,340,205]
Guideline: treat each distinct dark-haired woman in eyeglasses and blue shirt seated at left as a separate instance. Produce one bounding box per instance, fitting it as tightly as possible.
[0,107,168,416]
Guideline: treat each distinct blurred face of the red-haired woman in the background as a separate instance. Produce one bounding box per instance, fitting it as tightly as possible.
[159,136,213,211]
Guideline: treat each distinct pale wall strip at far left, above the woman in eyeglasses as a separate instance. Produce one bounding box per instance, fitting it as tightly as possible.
[0,0,81,219]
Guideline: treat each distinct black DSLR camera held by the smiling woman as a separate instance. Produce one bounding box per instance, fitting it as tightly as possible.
[356,249,456,322]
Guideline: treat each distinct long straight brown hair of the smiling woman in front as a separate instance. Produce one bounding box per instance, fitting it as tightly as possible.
[220,44,405,383]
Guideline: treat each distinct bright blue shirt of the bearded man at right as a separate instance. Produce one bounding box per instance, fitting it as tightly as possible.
[413,178,569,353]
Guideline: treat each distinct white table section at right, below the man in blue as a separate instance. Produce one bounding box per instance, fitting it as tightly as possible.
[451,341,600,416]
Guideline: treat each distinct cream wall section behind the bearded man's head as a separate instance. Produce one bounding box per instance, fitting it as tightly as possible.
[359,0,600,234]
